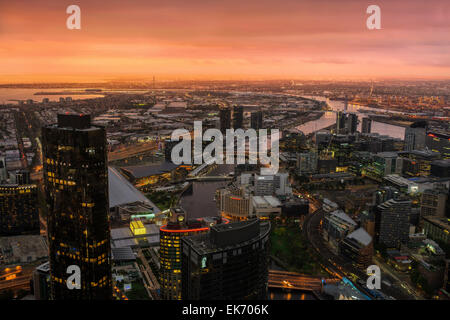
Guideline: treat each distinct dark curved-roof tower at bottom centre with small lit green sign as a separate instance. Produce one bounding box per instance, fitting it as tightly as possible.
[182,219,270,300]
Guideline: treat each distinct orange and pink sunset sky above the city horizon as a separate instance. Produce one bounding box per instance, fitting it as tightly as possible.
[0,0,450,83]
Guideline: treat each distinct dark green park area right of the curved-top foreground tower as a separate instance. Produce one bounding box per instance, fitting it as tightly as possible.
[270,225,325,275]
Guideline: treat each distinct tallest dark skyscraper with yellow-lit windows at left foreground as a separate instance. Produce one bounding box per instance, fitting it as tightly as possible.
[42,115,112,299]
